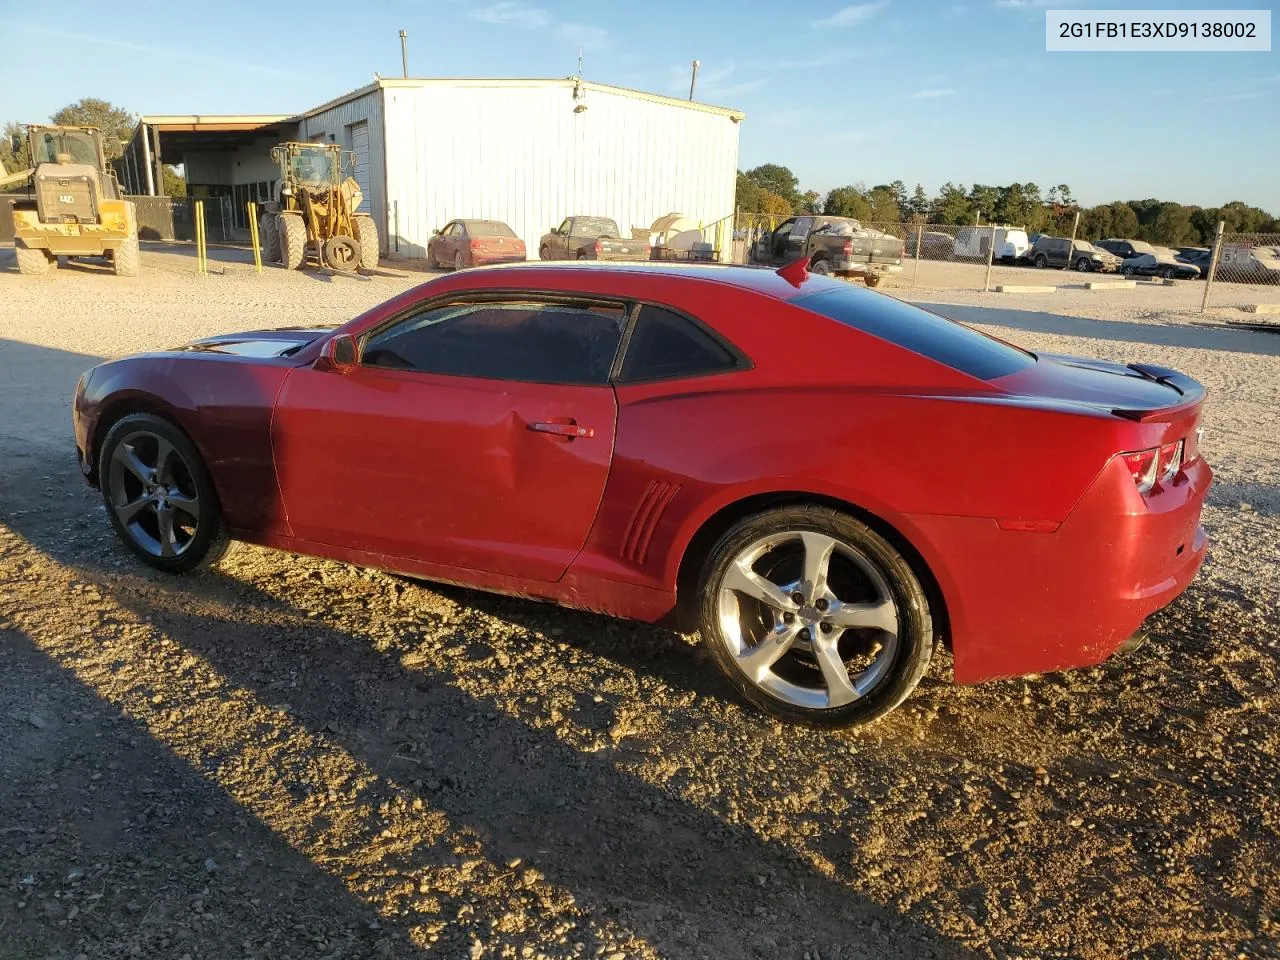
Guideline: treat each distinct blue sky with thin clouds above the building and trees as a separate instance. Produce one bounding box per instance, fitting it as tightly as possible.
[0,0,1280,212]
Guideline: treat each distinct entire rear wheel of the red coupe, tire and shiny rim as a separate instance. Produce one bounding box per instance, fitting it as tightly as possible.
[699,506,934,727]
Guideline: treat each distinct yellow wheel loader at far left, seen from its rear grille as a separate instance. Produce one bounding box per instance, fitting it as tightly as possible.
[0,124,138,276]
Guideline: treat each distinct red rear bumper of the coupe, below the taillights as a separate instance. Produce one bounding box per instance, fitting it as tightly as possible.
[910,458,1212,684]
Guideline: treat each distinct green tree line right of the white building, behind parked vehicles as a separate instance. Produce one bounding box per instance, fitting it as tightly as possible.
[736,164,1280,247]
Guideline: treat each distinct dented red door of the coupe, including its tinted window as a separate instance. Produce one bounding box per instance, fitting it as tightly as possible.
[273,296,626,581]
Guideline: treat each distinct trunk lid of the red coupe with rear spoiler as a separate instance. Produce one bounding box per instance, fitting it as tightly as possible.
[998,353,1204,412]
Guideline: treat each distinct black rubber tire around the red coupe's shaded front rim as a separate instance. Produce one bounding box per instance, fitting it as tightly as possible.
[97,413,230,573]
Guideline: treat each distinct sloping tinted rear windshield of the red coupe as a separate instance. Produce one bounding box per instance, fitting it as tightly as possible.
[791,284,1036,380]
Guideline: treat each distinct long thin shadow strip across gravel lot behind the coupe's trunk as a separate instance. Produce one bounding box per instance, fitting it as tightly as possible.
[920,301,1280,360]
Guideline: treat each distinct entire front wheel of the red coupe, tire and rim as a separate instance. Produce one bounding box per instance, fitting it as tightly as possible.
[99,413,230,573]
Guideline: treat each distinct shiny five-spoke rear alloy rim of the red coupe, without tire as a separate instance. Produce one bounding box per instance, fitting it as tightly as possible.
[717,530,900,709]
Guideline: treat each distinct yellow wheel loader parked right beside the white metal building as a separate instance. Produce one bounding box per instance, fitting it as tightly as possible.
[259,142,378,273]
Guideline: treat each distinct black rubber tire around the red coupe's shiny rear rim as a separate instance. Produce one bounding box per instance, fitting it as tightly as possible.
[698,504,934,727]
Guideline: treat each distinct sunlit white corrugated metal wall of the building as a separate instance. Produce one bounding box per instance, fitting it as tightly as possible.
[375,82,739,257]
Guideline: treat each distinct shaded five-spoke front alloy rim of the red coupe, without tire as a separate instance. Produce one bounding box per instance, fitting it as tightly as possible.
[106,430,200,558]
